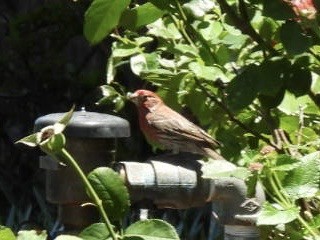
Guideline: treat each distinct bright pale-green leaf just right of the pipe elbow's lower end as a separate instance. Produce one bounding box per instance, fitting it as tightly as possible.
[257,202,299,225]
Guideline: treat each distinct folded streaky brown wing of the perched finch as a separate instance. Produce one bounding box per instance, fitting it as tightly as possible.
[147,106,220,147]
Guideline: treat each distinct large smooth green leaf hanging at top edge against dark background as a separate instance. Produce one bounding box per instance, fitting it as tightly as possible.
[84,0,130,44]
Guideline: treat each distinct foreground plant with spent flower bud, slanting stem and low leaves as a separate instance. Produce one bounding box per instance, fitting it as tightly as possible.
[12,107,179,240]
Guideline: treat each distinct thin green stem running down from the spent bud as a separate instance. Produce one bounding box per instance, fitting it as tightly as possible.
[54,148,118,240]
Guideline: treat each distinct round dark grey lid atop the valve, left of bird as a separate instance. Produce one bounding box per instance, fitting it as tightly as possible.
[34,111,130,138]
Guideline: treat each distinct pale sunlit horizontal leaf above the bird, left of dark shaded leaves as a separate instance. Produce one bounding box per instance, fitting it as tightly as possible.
[189,62,226,81]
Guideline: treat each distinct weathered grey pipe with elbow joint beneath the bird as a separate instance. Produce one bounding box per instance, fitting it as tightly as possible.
[117,154,265,239]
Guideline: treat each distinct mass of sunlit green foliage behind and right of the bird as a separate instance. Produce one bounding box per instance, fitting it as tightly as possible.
[85,0,320,239]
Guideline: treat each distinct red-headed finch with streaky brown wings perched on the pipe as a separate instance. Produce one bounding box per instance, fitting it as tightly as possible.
[129,90,223,159]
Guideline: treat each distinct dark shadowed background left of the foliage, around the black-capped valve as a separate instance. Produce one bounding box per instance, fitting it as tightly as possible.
[0,0,150,231]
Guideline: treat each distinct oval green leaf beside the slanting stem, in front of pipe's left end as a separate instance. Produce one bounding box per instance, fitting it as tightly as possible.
[88,167,130,220]
